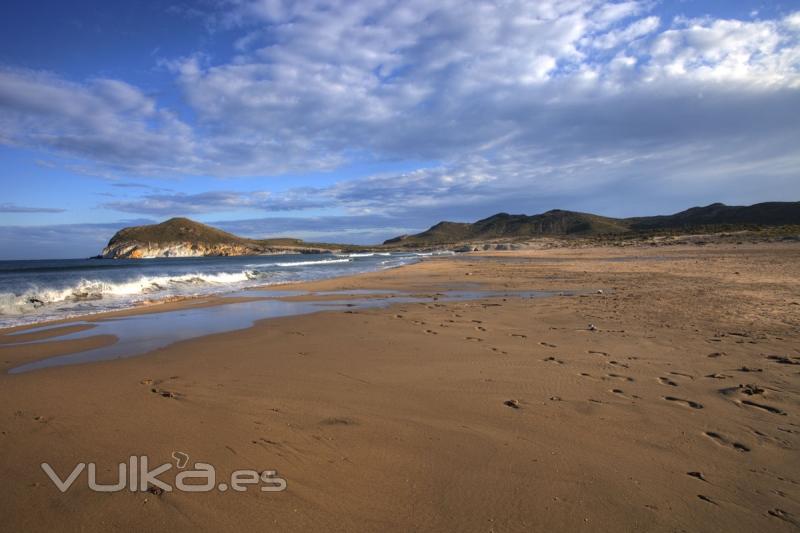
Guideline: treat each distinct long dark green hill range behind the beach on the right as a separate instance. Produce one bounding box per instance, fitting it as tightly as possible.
[384,202,800,247]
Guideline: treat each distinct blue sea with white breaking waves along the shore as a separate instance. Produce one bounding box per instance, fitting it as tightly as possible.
[0,252,447,328]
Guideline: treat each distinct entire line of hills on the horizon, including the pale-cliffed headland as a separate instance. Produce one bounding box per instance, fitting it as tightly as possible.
[98,202,800,259]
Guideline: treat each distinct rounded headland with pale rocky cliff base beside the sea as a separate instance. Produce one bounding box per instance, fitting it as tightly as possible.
[100,218,342,259]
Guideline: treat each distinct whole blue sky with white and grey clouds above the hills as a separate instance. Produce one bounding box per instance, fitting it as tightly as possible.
[0,0,800,259]
